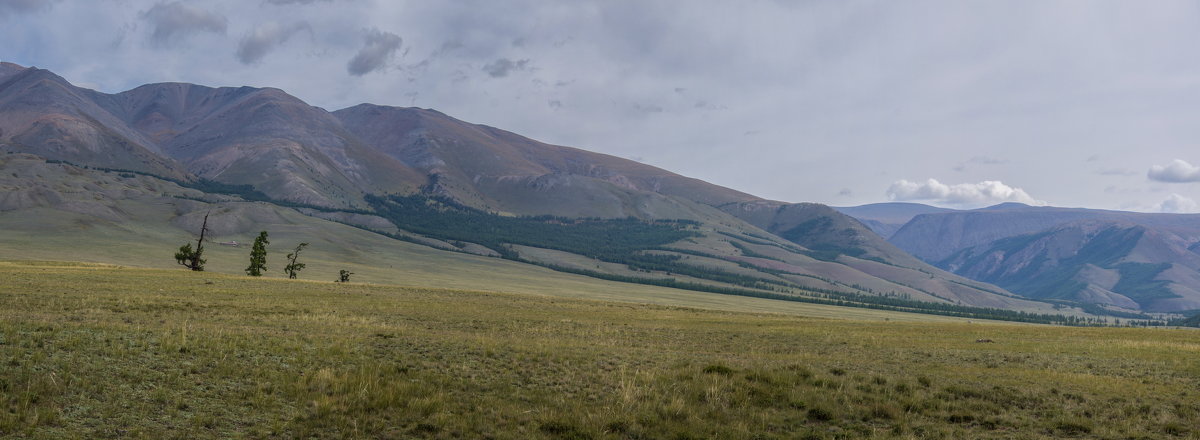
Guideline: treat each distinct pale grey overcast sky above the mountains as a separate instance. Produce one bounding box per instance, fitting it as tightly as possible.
[0,0,1200,212]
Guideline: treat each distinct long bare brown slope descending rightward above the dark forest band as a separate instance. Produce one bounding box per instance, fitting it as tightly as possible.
[334,104,755,217]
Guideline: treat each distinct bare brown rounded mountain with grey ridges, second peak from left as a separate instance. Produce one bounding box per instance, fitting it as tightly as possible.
[104,83,425,207]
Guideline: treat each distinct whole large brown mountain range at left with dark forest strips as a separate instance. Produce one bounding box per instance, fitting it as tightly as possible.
[0,65,1080,312]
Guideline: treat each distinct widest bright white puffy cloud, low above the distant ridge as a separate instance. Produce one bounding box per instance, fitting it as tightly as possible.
[887,179,1045,207]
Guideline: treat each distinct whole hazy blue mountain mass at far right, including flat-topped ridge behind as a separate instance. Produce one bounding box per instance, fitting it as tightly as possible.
[852,204,1200,312]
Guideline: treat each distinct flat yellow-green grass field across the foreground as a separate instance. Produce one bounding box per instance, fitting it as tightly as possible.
[0,261,1200,439]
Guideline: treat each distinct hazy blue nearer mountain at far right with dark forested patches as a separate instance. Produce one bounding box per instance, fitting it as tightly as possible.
[937,221,1200,312]
